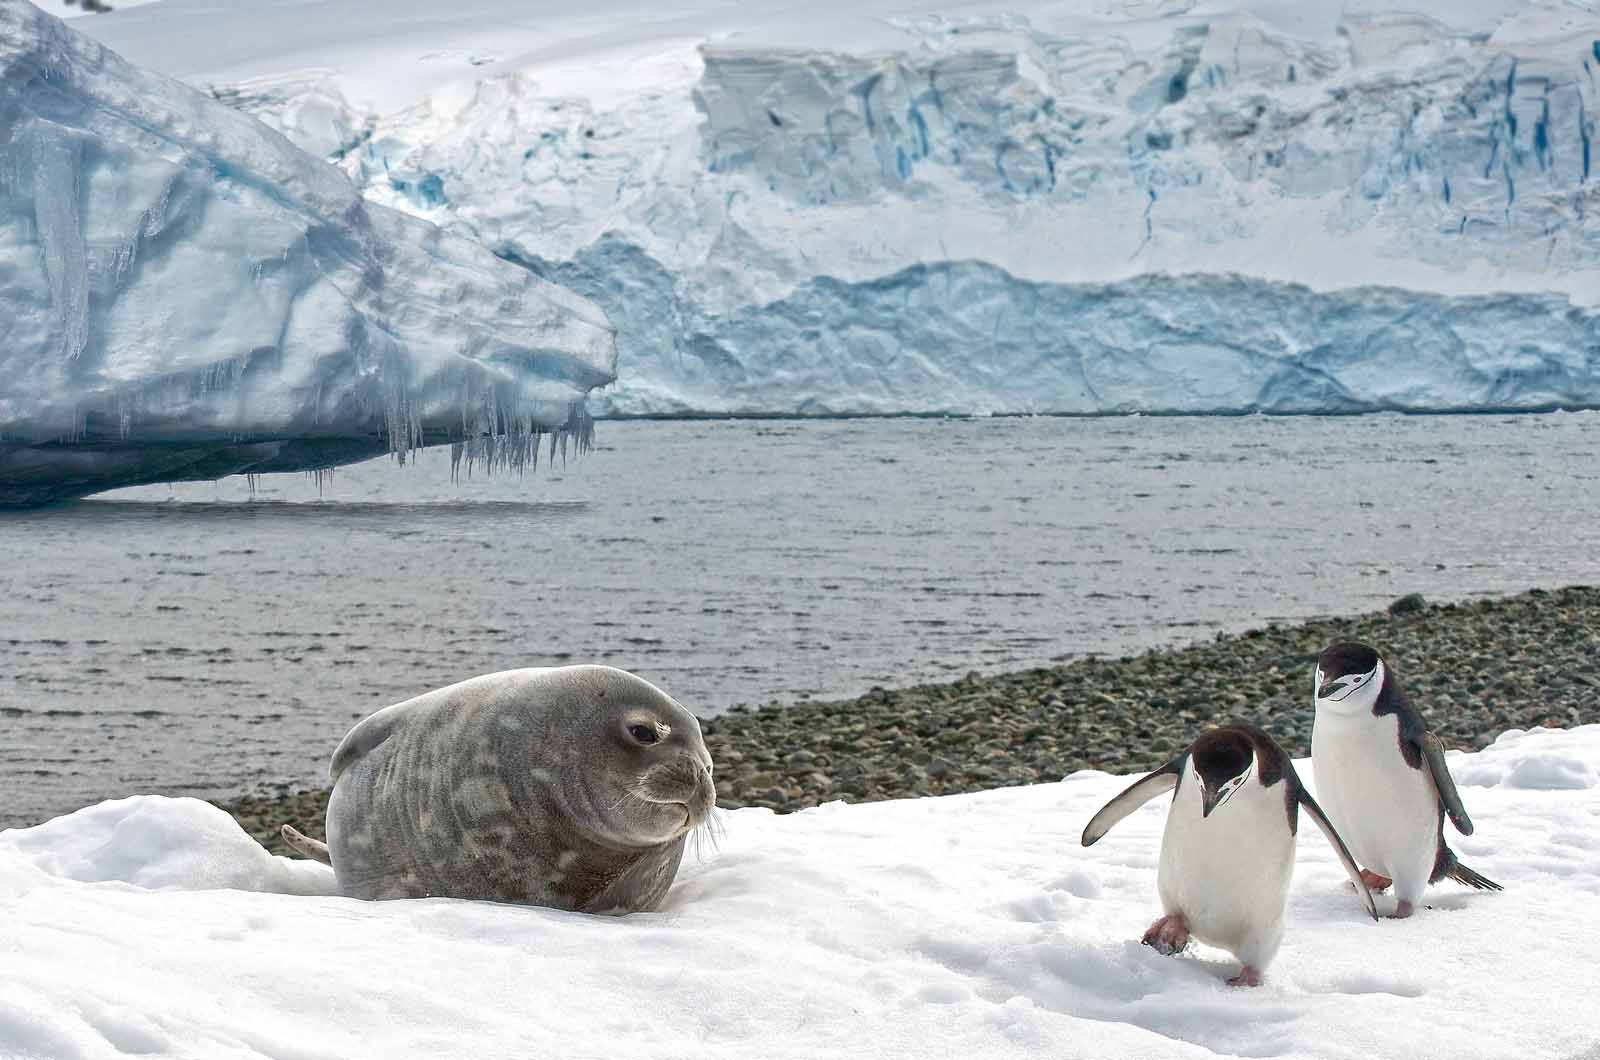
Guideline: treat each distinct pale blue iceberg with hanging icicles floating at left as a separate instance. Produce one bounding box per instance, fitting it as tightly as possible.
[0,0,616,506]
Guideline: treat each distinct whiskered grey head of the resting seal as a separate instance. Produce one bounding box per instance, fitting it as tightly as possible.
[537,666,717,847]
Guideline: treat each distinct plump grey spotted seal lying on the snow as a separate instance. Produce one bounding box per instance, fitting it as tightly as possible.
[283,666,717,913]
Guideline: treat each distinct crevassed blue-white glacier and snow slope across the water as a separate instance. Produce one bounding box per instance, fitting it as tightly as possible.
[90,0,1600,415]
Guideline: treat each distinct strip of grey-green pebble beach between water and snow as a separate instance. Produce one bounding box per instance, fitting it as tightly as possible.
[224,586,1600,853]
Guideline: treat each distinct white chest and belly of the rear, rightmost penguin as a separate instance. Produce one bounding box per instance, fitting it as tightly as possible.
[1310,706,1438,877]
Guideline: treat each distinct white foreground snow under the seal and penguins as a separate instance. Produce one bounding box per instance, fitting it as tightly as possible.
[0,725,1600,1060]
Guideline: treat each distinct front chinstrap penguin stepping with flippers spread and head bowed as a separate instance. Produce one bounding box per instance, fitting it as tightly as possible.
[1083,722,1378,986]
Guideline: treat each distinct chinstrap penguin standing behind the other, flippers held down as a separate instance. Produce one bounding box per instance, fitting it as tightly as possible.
[1310,642,1501,917]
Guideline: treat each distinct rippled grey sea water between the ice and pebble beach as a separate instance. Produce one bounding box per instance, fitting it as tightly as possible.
[0,413,1600,826]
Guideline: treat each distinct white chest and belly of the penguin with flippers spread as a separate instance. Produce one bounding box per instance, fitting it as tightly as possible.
[1157,772,1294,967]
